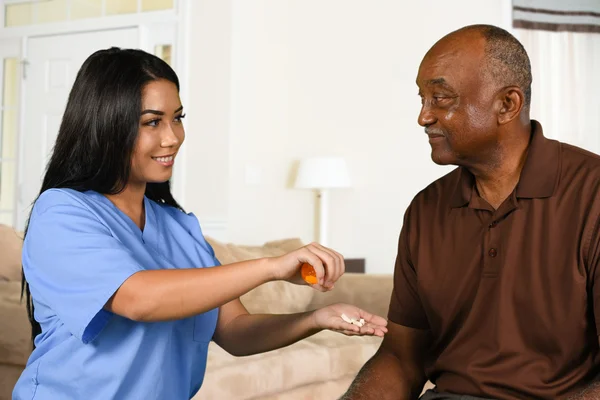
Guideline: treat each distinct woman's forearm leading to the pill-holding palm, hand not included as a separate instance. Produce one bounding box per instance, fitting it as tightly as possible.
[217,311,321,356]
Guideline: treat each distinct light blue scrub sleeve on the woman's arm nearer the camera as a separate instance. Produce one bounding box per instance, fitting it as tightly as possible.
[23,190,143,343]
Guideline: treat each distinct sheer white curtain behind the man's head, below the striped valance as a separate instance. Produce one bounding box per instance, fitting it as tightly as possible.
[513,29,600,154]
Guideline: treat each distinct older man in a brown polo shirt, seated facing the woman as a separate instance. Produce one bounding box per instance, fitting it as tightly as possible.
[343,25,600,400]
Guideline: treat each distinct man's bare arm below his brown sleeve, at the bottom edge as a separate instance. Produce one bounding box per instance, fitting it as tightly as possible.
[340,321,431,400]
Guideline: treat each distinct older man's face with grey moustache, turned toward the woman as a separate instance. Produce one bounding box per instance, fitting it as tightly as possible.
[417,33,498,166]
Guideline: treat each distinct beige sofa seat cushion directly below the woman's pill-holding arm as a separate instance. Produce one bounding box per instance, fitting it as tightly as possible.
[194,331,381,400]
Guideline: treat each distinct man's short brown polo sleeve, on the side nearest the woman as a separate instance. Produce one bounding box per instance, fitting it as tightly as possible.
[388,202,429,329]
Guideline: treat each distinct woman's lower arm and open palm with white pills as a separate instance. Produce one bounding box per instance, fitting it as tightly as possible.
[213,299,387,357]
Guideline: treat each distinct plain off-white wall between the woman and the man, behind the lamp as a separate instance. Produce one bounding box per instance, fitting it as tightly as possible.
[184,0,509,273]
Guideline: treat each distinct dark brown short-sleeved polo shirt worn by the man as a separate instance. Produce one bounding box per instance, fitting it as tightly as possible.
[389,121,600,399]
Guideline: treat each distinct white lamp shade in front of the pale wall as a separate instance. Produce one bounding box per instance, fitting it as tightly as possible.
[294,157,351,189]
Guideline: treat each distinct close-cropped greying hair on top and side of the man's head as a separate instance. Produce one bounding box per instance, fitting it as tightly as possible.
[430,25,532,109]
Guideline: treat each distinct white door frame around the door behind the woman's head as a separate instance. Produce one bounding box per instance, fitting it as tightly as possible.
[0,0,191,230]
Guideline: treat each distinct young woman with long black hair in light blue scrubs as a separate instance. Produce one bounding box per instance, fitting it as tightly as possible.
[13,48,386,400]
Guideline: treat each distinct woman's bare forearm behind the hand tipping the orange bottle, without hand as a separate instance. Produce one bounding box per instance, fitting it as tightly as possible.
[105,258,273,322]
